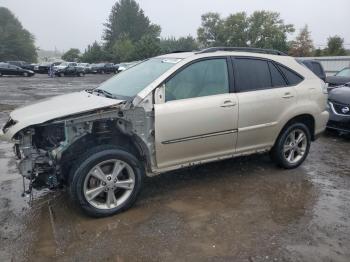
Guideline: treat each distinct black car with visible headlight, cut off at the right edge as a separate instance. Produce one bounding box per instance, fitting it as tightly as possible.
[327,83,350,133]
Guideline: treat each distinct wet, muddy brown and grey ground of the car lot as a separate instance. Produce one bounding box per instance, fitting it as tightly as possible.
[0,76,350,262]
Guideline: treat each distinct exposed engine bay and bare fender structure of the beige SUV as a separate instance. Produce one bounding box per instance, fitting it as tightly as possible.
[10,104,155,194]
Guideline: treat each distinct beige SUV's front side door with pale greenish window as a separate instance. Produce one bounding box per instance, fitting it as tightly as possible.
[154,58,238,168]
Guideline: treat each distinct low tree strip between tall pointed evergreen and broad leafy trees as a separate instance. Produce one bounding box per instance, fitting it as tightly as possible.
[160,36,198,54]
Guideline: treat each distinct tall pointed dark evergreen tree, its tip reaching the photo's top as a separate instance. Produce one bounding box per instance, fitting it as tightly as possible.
[103,0,161,48]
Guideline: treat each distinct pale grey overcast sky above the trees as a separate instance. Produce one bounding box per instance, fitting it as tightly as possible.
[0,0,350,51]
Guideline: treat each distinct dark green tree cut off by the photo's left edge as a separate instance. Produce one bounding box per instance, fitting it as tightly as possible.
[0,7,38,62]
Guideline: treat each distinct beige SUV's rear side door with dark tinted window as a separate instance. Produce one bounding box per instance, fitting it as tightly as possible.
[233,57,302,153]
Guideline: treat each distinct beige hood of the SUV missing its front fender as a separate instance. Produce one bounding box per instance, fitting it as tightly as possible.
[5,91,124,140]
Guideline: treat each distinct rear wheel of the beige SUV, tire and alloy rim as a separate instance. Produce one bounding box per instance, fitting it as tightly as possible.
[270,123,311,169]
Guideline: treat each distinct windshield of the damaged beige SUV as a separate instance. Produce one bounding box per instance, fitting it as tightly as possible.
[98,58,180,97]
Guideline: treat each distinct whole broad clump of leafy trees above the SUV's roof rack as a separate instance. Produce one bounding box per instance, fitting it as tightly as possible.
[197,11,294,51]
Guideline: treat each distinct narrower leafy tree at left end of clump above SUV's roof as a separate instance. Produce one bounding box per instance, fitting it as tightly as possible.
[197,13,224,47]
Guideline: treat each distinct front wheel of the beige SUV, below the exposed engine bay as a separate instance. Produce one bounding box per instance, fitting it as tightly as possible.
[69,145,144,217]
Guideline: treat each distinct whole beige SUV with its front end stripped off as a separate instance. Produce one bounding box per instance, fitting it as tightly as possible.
[3,48,328,217]
